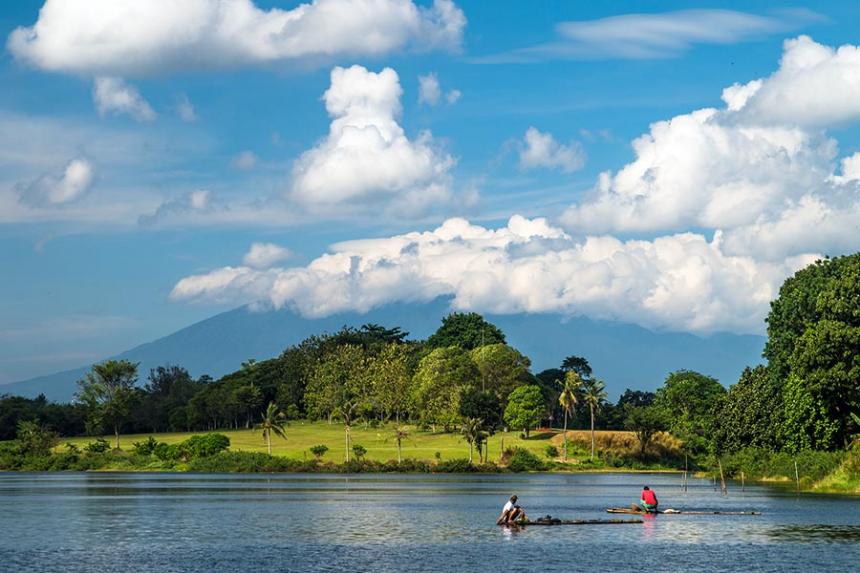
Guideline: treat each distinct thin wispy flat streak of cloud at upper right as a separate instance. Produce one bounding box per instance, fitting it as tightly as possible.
[478,9,822,63]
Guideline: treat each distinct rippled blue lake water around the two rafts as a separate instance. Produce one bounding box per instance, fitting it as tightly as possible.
[0,473,860,573]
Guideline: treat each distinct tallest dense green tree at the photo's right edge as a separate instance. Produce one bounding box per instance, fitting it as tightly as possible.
[764,253,860,449]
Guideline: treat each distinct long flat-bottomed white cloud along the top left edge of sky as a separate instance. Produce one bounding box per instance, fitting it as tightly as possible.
[7,0,466,77]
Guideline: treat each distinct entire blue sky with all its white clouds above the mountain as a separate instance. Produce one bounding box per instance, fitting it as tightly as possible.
[0,0,860,383]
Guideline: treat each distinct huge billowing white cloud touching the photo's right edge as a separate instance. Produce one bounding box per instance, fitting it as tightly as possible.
[560,37,860,259]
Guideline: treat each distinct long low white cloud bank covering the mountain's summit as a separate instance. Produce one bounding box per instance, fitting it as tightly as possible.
[171,216,813,332]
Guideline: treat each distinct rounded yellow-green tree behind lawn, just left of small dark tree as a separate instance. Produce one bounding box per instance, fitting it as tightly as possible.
[413,346,479,430]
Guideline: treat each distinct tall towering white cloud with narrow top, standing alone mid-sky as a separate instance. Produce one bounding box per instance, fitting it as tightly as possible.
[291,66,454,214]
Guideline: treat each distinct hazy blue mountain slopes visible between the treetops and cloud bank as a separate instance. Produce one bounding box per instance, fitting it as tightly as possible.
[0,299,764,401]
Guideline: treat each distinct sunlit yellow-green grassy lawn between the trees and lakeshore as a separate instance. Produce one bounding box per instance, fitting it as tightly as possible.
[57,421,620,462]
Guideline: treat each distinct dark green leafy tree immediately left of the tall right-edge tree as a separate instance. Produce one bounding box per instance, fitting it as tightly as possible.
[711,366,783,454]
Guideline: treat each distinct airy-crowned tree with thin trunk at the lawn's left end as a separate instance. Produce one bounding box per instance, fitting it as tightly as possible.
[77,360,137,449]
